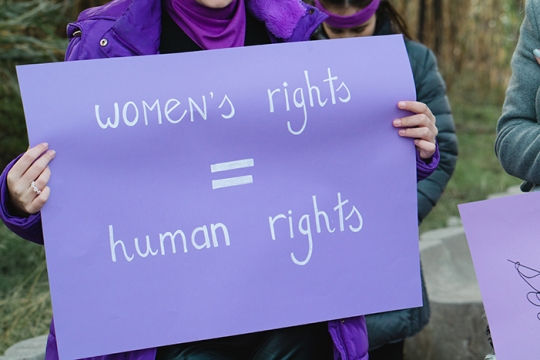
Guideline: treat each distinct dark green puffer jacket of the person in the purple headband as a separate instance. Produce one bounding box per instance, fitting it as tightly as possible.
[314,18,458,350]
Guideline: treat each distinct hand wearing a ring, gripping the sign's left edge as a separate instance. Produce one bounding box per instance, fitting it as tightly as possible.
[7,143,56,217]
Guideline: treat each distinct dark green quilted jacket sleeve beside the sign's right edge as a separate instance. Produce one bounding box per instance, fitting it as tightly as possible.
[407,41,458,222]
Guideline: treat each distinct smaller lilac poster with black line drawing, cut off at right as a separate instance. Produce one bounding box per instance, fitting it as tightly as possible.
[459,192,540,360]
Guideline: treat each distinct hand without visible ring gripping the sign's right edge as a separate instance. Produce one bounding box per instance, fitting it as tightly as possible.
[393,101,439,159]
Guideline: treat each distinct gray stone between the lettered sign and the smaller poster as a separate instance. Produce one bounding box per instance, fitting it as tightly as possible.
[405,226,492,360]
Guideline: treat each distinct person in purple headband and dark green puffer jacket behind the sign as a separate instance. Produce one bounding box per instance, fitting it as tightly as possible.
[313,0,458,360]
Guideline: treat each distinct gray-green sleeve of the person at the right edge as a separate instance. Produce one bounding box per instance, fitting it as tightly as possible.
[495,1,540,188]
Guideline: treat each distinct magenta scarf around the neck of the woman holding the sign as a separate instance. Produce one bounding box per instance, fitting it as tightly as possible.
[165,0,246,50]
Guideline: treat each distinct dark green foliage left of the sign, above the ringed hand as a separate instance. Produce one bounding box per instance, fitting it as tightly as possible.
[0,0,68,168]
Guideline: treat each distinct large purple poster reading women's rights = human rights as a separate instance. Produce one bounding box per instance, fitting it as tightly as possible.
[18,36,421,358]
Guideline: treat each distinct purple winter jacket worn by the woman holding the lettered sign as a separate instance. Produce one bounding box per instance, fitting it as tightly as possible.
[0,0,439,360]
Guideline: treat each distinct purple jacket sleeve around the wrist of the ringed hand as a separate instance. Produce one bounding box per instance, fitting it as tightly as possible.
[0,155,43,244]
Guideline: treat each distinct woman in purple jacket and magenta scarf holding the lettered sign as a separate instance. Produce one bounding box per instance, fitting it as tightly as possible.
[0,0,439,360]
